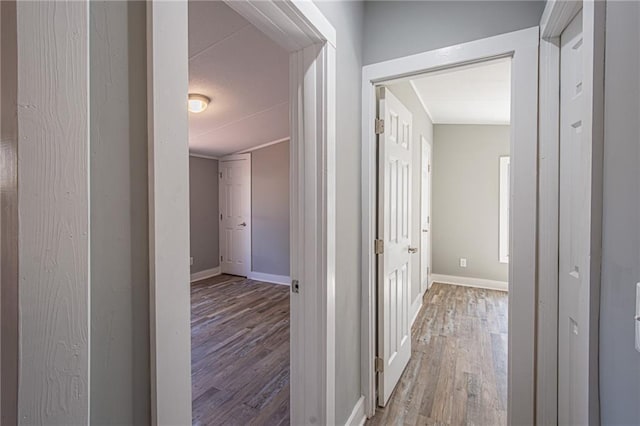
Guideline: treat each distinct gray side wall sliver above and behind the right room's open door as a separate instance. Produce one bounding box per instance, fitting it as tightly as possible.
[389,81,433,302]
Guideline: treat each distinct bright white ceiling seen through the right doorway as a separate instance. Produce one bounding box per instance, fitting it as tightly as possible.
[410,58,511,124]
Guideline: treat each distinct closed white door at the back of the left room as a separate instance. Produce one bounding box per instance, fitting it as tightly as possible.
[219,154,251,277]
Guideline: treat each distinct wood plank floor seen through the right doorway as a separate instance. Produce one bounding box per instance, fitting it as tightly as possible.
[367,283,508,426]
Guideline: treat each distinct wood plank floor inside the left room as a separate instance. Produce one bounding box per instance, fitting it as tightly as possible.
[191,275,289,425]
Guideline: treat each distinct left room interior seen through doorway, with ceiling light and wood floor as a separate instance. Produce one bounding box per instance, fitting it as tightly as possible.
[189,1,290,425]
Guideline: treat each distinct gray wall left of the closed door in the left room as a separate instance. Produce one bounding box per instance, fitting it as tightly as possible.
[189,156,220,274]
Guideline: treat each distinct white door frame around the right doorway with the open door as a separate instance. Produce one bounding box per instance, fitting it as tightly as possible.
[361,27,539,424]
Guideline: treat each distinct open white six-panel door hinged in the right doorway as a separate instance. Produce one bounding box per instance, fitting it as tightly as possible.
[377,88,416,406]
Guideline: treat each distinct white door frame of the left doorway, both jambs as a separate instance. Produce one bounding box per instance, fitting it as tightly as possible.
[147,0,336,425]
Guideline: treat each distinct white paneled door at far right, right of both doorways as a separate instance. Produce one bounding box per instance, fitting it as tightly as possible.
[558,12,591,425]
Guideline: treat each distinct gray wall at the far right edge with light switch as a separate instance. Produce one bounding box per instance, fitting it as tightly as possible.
[600,1,640,425]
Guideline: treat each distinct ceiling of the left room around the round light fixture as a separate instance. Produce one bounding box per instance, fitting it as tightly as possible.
[189,0,289,157]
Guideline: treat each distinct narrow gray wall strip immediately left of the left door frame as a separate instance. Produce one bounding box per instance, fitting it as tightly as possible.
[90,1,151,424]
